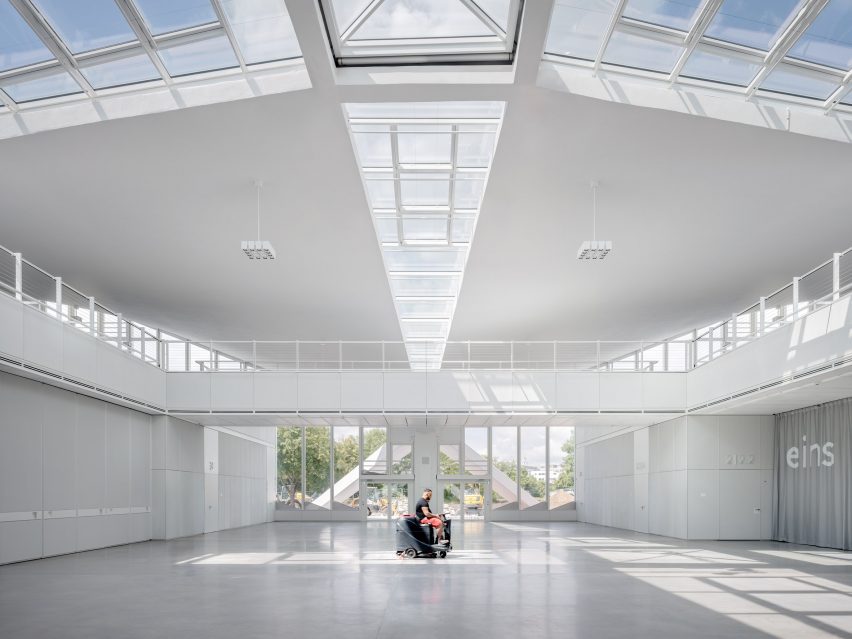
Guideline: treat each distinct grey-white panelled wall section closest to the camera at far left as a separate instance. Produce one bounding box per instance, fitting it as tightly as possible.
[0,373,152,564]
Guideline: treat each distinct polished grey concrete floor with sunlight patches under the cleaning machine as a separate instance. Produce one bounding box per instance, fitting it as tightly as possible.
[0,522,852,639]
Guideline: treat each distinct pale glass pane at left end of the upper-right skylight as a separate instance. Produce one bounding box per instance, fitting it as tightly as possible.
[544,0,616,60]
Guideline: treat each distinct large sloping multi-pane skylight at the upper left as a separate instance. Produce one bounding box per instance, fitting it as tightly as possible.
[0,0,301,110]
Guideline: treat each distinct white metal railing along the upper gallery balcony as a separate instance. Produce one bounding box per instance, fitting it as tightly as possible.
[0,247,852,372]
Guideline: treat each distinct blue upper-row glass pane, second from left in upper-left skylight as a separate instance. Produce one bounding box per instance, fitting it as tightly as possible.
[32,0,136,54]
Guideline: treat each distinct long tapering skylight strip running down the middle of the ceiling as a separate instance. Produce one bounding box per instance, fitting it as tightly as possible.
[346,102,504,370]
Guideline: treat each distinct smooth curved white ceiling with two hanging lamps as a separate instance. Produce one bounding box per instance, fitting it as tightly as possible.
[0,2,852,348]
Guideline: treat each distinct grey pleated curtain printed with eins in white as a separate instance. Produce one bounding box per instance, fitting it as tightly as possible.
[773,398,852,550]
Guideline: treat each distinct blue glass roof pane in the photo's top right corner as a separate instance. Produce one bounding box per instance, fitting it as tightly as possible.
[789,0,852,71]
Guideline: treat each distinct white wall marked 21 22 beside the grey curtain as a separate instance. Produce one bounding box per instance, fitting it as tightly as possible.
[577,415,774,539]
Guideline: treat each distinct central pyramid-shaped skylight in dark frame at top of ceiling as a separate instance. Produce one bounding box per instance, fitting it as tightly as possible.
[321,0,522,66]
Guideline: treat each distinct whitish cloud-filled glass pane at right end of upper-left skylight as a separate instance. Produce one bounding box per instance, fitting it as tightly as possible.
[222,0,302,64]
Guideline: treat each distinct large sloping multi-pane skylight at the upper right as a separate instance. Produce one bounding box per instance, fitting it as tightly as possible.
[545,0,852,111]
